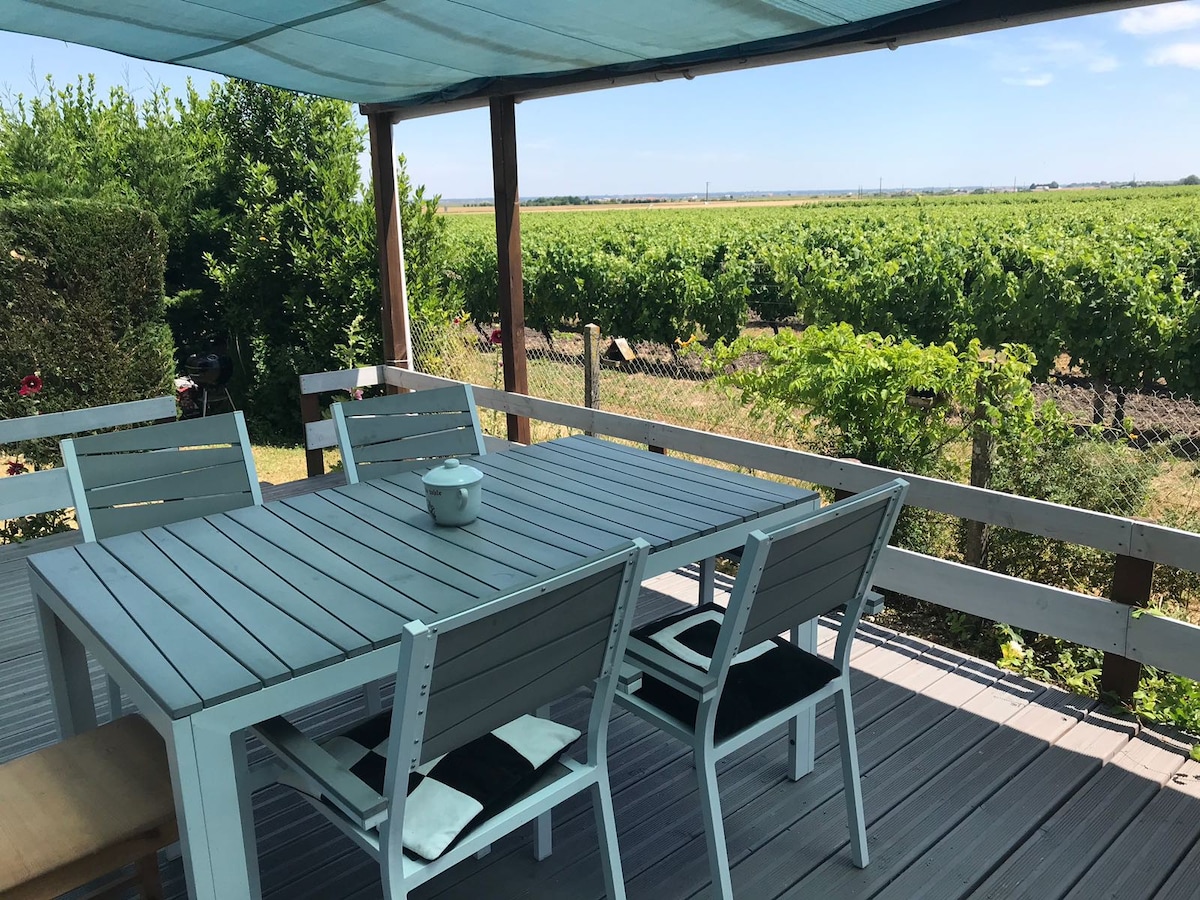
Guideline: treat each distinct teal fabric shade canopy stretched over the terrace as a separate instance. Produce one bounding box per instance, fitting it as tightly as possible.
[0,0,1148,119]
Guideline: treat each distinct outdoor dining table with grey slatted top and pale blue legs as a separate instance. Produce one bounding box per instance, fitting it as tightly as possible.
[30,436,818,900]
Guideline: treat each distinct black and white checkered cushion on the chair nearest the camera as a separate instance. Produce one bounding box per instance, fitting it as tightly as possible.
[280,710,580,860]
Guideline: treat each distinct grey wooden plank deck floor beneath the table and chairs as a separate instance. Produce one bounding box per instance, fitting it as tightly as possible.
[0,475,1200,900]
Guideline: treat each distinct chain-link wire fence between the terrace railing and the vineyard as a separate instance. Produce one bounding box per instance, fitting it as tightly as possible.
[413,323,1200,530]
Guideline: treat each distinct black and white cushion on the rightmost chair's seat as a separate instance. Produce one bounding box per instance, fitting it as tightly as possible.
[631,604,839,740]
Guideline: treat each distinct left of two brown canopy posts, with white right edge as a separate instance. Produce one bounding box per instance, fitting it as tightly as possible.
[367,113,413,381]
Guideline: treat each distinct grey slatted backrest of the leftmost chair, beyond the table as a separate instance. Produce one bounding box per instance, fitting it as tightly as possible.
[62,412,263,540]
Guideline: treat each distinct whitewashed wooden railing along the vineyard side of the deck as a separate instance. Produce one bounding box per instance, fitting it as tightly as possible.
[300,366,1200,679]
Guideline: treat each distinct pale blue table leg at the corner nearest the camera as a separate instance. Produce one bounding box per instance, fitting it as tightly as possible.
[170,719,262,900]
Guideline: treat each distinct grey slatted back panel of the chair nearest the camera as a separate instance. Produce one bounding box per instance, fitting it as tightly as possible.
[422,568,626,760]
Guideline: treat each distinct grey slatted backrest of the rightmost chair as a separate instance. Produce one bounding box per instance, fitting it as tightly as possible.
[722,479,907,652]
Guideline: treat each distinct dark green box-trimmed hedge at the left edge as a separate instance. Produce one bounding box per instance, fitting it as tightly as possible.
[0,200,174,455]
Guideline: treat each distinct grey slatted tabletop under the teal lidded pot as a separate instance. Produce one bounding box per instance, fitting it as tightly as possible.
[30,437,815,718]
